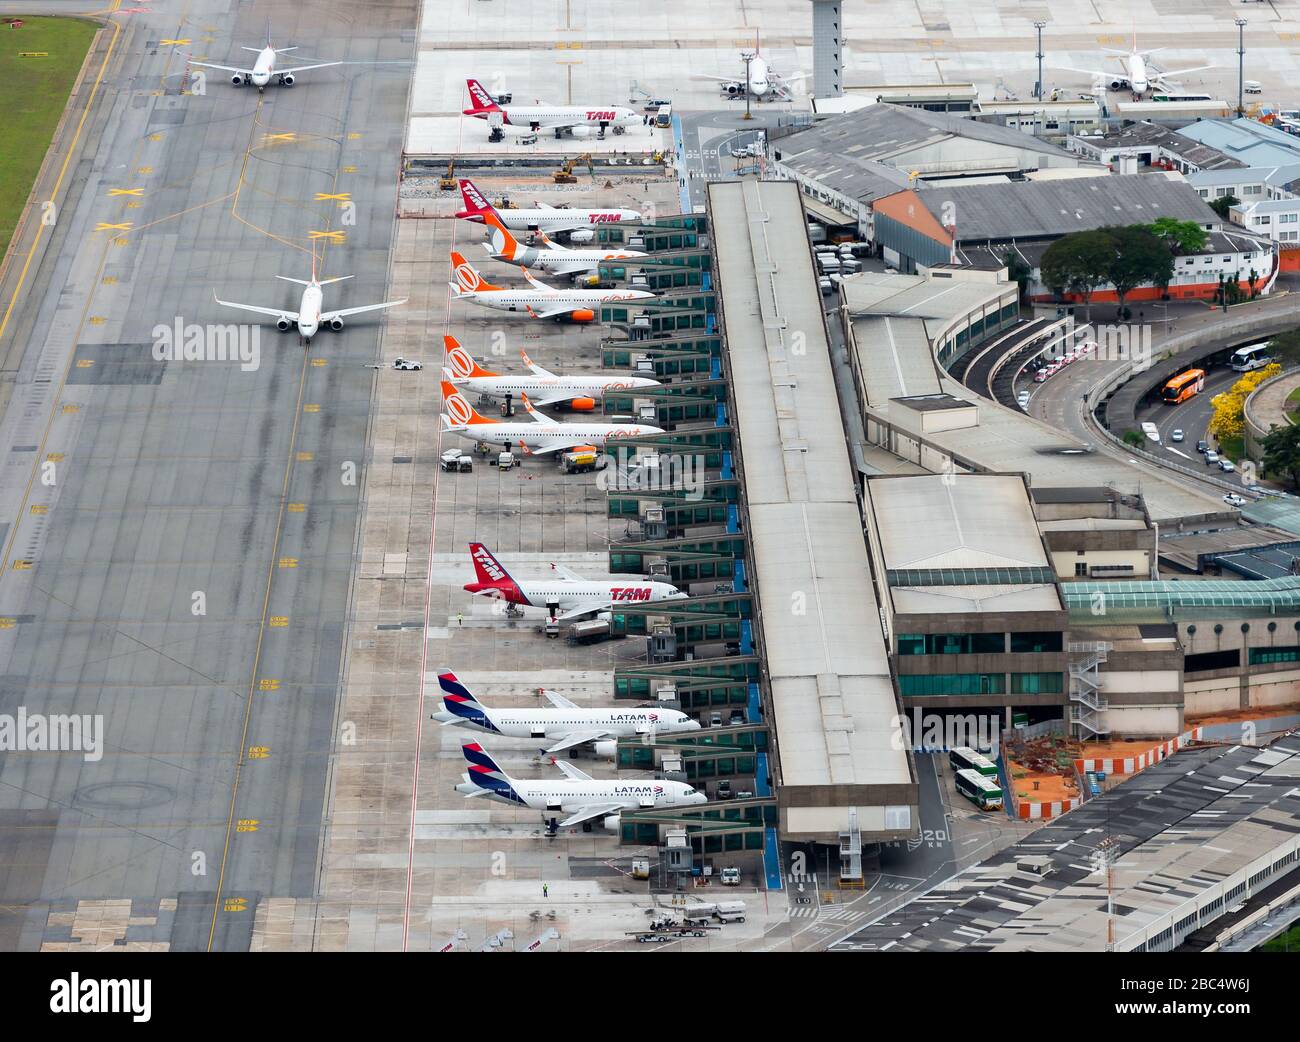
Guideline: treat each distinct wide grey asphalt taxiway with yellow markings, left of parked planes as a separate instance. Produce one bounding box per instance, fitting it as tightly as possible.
[0,0,417,950]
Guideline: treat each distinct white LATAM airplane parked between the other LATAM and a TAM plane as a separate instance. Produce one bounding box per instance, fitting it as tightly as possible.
[433,669,699,760]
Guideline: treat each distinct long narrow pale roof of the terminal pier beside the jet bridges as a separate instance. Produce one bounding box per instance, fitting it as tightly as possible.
[709,181,915,805]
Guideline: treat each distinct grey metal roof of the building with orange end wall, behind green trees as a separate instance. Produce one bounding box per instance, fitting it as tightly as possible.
[917,174,1222,242]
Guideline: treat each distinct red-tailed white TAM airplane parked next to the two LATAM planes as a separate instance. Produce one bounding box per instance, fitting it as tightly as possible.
[464,543,689,622]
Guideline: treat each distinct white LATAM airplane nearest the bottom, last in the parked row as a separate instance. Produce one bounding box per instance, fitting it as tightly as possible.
[456,742,709,833]
